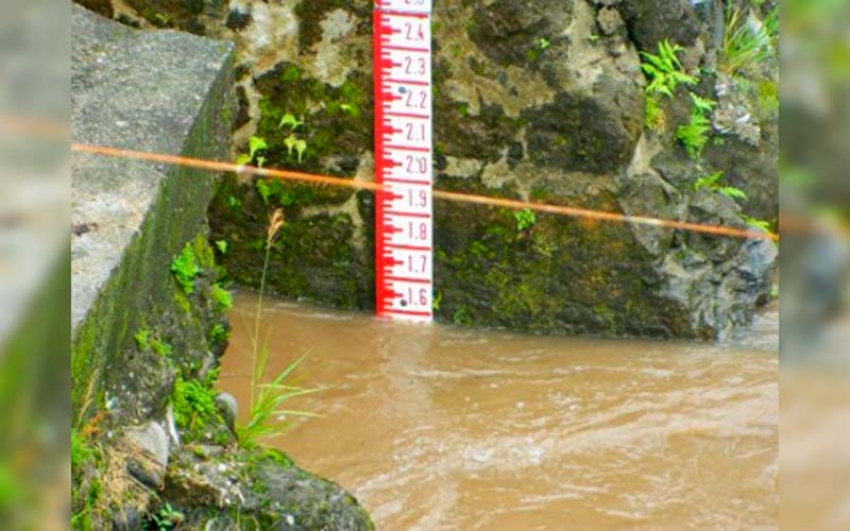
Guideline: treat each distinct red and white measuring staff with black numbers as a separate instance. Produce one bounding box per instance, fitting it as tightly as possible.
[373,0,434,322]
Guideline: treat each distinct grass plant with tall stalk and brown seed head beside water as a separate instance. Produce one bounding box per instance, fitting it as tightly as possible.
[236,208,320,446]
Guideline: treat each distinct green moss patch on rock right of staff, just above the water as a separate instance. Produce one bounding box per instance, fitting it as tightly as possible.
[435,179,675,336]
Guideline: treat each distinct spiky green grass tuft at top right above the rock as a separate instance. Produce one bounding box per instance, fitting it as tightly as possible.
[720,2,779,76]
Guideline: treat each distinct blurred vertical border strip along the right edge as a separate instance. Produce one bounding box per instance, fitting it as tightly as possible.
[780,0,850,530]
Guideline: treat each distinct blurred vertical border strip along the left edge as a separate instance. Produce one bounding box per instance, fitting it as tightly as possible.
[0,0,70,530]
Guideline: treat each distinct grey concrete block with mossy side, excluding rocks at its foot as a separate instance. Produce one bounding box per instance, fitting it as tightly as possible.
[71,2,233,428]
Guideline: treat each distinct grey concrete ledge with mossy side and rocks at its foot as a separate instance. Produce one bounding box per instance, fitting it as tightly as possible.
[73,5,372,530]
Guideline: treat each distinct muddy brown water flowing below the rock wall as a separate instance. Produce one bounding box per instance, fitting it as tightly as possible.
[221,293,779,530]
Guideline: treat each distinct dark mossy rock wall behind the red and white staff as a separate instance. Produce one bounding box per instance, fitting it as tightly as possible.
[86,0,777,338]
